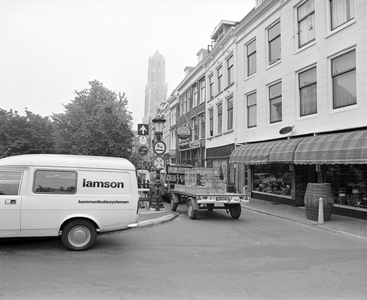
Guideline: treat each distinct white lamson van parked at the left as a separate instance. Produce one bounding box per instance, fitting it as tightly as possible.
[0,154,139,250]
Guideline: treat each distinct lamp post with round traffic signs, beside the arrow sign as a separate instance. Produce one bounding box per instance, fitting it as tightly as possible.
[152,116,167,211]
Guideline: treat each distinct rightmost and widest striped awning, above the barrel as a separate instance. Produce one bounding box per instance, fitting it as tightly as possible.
[294,130,367,164]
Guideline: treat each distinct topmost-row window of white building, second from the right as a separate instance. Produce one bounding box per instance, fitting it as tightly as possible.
[297,0,315,48]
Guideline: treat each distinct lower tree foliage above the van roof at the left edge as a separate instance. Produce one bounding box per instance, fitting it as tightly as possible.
[0,109,54,157]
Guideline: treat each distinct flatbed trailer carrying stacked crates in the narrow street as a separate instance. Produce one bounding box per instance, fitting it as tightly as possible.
[170,185,250,220]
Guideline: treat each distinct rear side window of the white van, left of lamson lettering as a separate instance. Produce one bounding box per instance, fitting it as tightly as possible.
[33,170,77,194]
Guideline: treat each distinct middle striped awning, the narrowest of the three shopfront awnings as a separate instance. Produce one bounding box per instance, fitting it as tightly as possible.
[269,138,304,164]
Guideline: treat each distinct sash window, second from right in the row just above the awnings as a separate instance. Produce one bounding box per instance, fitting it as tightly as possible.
[299,67,317,116]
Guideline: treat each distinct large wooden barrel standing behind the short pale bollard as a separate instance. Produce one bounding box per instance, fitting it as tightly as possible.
[305,183,334,221]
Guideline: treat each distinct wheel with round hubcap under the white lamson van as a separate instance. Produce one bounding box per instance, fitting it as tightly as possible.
[61,220,97,251]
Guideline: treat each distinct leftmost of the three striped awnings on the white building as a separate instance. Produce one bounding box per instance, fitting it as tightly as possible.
[229,142,277,165]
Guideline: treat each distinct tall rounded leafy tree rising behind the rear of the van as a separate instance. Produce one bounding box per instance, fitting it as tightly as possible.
[52,80,133,158]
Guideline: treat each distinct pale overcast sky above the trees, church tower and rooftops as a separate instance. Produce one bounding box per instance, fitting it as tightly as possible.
[0,0,255,130]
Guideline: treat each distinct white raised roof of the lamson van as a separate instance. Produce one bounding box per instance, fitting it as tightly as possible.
[0,154,135,171]
